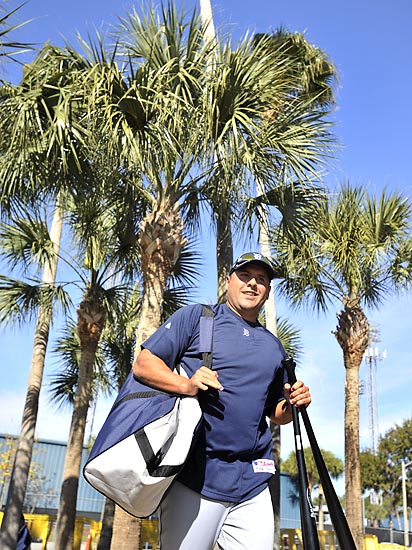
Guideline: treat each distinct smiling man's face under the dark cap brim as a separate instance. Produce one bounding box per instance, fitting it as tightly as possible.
[226,263,270,321]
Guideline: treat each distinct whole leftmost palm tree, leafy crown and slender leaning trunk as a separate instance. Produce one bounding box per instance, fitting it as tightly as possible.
[0,42,109,548]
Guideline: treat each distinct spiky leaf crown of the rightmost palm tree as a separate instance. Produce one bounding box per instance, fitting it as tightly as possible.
[274,184,412,309]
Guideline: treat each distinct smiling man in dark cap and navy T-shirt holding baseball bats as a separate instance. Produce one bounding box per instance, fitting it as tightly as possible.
[133,252,311,550]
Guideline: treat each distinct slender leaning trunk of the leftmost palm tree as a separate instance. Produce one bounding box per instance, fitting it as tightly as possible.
[0,205,63,550]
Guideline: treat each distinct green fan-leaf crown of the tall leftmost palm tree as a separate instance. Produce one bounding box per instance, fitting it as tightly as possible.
[0,46,94,207]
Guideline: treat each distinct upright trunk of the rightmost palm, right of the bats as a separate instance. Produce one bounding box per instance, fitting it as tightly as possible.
[335,306,369,548]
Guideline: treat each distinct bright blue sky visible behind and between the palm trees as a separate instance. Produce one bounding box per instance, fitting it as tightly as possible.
[0,0,412,492]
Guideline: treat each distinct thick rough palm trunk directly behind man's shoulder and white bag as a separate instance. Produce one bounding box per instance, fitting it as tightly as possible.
[110,209,186,550]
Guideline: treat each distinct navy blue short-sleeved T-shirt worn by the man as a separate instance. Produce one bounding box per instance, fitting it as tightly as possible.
[142,304,287,502]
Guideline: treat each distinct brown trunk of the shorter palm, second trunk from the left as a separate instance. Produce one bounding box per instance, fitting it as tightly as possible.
[55,296,106,550]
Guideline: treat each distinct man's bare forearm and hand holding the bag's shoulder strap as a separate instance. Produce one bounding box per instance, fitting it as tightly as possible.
[133,349,223,395]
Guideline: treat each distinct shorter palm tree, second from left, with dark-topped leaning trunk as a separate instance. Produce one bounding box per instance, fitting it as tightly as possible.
[2,179,143,548]
